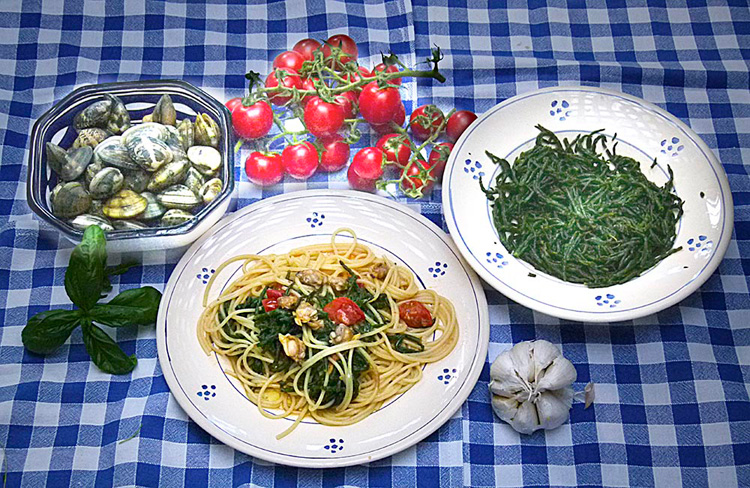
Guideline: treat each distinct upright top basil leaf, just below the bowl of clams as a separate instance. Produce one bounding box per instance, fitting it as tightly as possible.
[65,225,107,311]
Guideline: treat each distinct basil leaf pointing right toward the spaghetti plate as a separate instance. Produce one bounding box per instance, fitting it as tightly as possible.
[90,286,161,327]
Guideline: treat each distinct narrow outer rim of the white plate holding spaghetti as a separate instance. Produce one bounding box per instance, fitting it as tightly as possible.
[156,189,490,468]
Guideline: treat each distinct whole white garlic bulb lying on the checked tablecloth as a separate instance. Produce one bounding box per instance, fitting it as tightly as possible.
[490,340,576,434]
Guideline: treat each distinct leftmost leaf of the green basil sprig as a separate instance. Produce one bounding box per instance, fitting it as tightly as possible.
[21,310,81,354]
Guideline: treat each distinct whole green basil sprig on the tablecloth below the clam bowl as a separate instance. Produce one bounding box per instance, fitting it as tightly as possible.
[21,225,161,374]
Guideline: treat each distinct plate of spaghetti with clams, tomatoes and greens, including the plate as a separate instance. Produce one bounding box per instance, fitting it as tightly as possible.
[157,190,489,467]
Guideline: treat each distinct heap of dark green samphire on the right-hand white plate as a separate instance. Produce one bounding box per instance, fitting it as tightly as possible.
[480,125,683,288]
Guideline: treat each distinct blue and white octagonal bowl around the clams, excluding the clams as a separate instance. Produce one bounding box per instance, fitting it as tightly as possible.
[26,80,234,251]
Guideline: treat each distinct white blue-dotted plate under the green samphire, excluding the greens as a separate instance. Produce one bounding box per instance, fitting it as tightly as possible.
[443,87,734,322]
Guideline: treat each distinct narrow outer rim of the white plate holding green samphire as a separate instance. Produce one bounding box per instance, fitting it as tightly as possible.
[442,86,734,323]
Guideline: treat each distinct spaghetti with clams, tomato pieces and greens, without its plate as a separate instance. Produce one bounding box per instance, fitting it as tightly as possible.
[198,229,458,438]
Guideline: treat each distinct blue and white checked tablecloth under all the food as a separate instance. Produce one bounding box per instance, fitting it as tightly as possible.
[0,0,750,488]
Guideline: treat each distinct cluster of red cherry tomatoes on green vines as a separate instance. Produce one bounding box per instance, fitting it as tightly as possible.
[226,34,476,197]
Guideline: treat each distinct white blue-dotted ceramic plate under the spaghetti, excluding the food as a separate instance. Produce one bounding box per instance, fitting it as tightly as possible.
[157,190,489,467]
